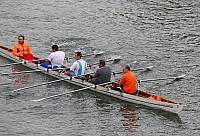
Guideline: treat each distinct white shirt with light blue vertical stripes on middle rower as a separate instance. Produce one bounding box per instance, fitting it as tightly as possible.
[70,59,87,76]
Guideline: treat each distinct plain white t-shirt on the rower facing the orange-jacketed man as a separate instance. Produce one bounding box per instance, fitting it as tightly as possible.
[48,51,65,67]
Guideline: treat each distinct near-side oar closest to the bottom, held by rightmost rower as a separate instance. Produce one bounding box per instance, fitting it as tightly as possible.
[32,81,115,102]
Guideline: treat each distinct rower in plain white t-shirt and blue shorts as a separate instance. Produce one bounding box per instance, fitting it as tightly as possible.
[40,45,65,68]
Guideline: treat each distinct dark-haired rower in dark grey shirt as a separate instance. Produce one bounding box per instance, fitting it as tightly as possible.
[88,60,111,85]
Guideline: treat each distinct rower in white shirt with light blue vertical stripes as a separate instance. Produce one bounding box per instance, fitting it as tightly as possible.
[65,52,87,77]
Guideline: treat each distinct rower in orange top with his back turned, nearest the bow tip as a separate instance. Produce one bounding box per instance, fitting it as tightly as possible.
[118,66,137,94]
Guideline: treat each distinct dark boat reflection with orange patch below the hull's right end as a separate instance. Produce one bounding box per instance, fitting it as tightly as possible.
[95,94,184,132]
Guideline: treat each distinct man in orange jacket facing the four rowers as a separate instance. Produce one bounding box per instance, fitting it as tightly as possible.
[12,35,33,60]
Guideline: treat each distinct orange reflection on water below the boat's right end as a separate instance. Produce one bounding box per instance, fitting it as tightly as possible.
[120,105,139,132]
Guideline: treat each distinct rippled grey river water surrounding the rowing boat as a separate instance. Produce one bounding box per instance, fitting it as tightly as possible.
[0,0,200,136]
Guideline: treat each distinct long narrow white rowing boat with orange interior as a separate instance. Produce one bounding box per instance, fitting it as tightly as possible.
[0,46,183,113]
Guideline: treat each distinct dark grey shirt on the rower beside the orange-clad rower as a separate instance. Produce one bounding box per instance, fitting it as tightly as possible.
[93,66,111,84]
